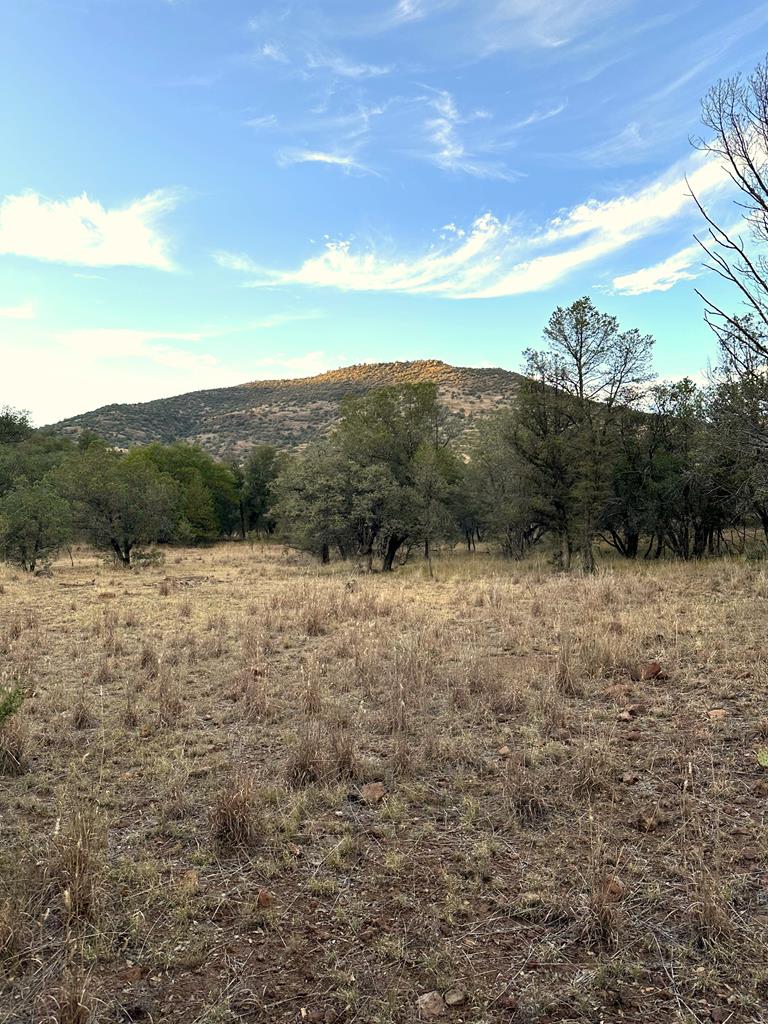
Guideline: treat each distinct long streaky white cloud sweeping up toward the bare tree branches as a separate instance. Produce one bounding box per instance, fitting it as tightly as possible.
[217,150,728,299]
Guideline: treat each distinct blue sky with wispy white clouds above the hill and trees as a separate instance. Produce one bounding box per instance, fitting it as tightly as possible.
[0,0,768,423]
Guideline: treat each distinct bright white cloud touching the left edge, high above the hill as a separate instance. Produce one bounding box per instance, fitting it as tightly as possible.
[0,189,179,270]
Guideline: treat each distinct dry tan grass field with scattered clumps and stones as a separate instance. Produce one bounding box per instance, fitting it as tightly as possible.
[0,545,768,1024]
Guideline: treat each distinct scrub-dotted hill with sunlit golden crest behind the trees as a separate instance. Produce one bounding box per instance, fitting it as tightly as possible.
[53,359,522,458]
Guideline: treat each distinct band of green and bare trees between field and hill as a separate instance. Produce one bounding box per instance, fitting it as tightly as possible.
[0,60,768,571]
